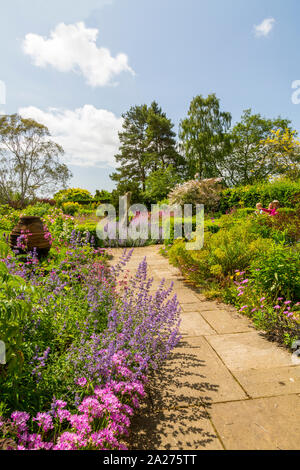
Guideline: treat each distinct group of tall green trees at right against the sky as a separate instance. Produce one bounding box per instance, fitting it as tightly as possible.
[111,94,300,202]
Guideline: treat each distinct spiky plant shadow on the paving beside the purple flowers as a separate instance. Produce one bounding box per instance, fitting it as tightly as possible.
[127,341,219,450]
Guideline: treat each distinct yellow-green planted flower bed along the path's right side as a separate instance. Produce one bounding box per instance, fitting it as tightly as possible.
[162,209,300,347]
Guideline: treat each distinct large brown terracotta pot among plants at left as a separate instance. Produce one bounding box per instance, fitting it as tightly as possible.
[10,216,51,256]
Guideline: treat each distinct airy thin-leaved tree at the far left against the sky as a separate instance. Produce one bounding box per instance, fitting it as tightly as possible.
[0,114,71,206]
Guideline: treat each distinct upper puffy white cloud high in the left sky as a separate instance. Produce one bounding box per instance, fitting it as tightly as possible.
[23,22,134,87]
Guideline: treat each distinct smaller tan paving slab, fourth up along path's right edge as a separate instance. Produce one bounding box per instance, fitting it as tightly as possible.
[200,306,254,334]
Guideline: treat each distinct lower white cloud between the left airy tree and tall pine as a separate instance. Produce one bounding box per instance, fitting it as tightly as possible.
[19,105,123,168]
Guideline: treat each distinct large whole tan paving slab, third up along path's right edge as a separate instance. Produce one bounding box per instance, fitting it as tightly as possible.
[207,331,292,372]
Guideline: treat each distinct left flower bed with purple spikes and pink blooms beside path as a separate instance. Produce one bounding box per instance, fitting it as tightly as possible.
[0,219,180,450]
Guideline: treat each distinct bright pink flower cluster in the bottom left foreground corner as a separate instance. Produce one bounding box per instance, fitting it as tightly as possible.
[0,364,145,450]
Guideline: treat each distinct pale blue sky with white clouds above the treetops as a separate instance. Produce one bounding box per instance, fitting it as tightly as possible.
[0,0,300,192]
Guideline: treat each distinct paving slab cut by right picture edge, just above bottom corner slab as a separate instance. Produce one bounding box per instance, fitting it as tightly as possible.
[234,366,300,396]
